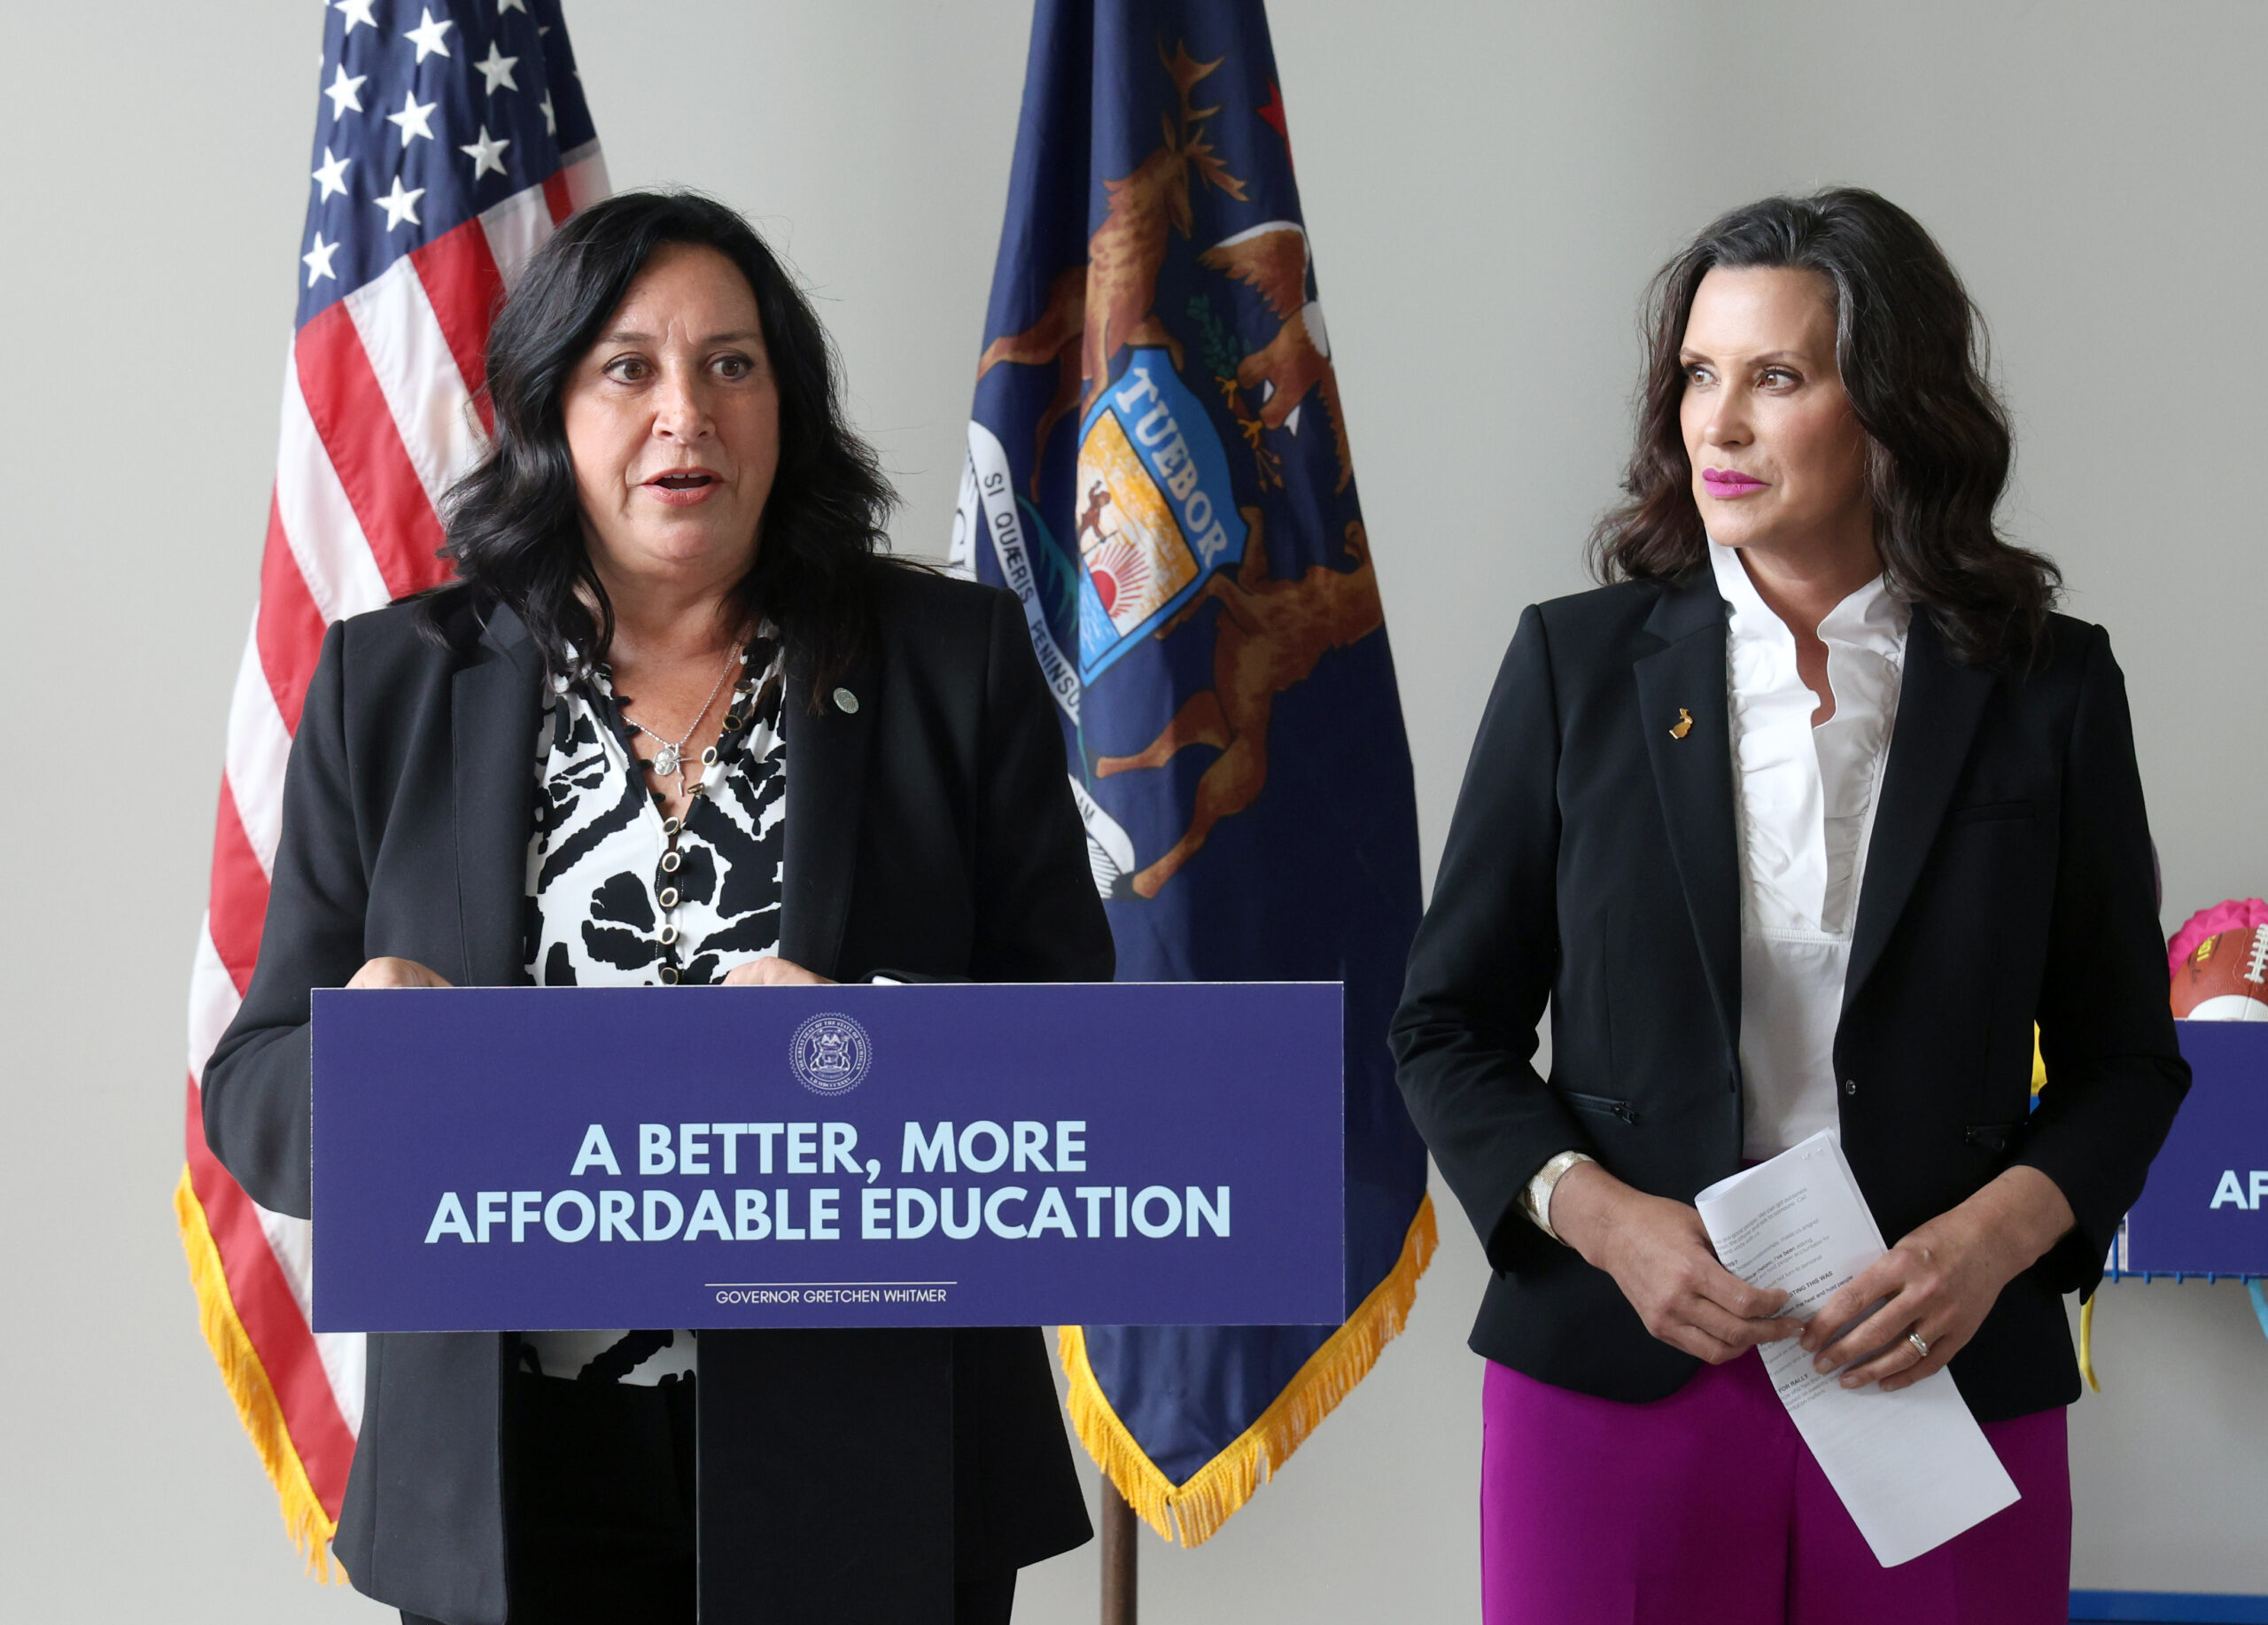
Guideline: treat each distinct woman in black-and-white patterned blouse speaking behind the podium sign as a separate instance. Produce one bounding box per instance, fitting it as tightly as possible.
[204,193,1114,1625]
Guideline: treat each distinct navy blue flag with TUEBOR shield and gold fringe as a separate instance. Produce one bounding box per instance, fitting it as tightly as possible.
[952,0,1433,1545]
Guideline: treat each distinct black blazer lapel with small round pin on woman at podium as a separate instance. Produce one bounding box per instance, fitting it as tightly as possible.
[781,658,880,976]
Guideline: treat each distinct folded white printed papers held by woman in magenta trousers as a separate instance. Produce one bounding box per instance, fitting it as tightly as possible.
[1694,1131,2016,1568]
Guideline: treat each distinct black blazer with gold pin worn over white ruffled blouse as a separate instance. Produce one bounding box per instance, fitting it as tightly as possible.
[1393,570,2188,1420]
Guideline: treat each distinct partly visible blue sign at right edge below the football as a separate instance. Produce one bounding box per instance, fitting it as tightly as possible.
[2114,1022,2268,1276]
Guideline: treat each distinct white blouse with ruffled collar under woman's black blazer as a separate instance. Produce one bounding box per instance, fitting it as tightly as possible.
[1708,542,1912,1160]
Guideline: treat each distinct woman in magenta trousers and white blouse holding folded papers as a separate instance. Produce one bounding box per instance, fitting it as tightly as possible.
[1394,190,2188,1625]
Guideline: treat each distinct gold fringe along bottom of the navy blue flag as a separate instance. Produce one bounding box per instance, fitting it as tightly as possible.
[1057,1196,1441,1545]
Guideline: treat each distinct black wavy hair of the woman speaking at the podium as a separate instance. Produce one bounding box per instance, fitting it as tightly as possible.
[424,190,896,695]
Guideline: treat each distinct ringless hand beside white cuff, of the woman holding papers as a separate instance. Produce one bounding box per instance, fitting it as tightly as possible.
[1551,1162,1803,1366]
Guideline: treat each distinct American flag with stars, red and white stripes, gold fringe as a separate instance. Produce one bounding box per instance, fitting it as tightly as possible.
[175,0,606,1571]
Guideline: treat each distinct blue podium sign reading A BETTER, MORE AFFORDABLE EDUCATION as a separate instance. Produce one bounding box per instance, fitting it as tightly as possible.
[313,983,1348,1333]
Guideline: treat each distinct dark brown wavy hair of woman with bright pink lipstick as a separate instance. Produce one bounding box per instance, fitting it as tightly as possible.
[1590,186,2062,665]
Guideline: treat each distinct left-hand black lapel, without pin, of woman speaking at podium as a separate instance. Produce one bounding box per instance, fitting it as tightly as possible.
[449,608,542,987]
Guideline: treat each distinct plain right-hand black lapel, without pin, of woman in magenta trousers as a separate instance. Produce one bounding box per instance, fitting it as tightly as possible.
[1844,606,1993,1010]
